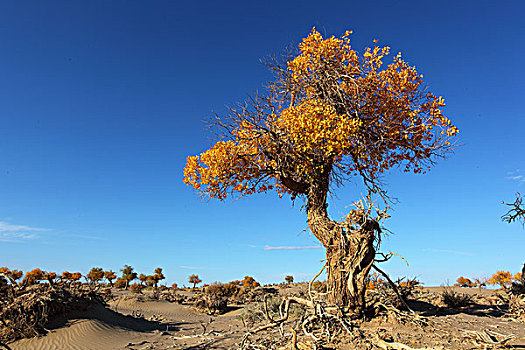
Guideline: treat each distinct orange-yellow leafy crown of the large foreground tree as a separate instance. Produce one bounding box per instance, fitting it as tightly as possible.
[184,28,458,200]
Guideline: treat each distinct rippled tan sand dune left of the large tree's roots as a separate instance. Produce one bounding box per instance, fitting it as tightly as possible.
[9,296,243,350]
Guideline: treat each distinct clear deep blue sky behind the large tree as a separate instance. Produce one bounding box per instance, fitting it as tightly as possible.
[0,1,525,285]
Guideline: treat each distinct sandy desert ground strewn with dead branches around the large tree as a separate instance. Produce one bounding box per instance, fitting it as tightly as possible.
[7,283,525,350]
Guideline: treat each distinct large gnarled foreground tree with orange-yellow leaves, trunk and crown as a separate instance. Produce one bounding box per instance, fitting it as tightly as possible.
[184,28,458,313]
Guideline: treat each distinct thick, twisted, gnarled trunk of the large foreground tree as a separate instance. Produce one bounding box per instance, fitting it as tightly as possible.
[307,179,380,314]
